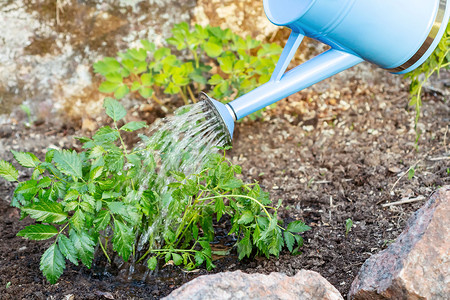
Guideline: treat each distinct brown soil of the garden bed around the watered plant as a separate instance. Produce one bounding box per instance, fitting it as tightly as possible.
[0,67,450,299]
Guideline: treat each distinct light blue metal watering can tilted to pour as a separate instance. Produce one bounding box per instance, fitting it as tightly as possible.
[201,0,450,142]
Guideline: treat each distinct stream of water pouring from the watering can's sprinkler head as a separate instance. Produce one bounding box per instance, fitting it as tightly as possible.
[129,101,228,273]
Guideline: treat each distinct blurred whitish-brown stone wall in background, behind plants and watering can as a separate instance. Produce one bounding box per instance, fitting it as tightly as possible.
[0,0,400,130]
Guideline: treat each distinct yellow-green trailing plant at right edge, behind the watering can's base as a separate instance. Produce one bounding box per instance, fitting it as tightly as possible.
[405,23,450,140]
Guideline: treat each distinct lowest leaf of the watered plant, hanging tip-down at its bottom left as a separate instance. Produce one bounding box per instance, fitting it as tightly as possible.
[39,244,66,284]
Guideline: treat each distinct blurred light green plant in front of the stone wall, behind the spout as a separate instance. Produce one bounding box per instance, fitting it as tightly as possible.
[94,22,282,118]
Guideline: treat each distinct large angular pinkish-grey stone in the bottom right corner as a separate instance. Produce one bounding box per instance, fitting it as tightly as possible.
[348,186,450,299]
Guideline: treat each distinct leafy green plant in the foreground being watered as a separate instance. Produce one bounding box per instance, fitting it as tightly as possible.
[0,98,310,283]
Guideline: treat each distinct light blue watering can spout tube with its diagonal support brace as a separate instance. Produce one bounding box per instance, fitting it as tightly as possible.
[226,31,363,120]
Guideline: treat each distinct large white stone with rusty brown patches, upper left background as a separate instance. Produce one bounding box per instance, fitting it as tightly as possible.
[0,0,196,125]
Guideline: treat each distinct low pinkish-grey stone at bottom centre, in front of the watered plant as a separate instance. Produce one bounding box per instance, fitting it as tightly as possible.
[164,270,343,300]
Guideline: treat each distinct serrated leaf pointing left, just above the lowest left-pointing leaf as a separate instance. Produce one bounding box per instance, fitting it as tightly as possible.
[22,200,67,223]
